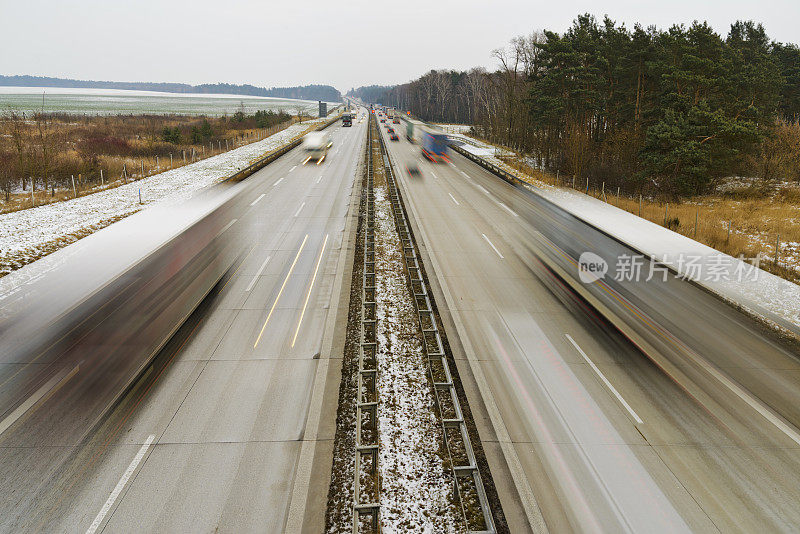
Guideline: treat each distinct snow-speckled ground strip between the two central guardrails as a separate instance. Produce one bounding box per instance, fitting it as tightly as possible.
[374,173,463,534]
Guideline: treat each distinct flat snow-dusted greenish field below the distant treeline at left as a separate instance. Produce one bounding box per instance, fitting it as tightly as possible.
[0,87,338,117]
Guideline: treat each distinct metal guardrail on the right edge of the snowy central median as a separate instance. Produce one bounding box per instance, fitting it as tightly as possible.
[378,129,496,534]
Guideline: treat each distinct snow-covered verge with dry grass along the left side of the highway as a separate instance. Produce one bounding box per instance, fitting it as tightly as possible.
[0,115,325,278]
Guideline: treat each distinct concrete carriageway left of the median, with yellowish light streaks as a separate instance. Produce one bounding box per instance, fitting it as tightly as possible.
[0,115,366,532]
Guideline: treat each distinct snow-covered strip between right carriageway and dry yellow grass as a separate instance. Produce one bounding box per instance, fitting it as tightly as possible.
[451,135,800,334]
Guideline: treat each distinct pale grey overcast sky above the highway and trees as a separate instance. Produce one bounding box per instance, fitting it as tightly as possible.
[0,0,800,92]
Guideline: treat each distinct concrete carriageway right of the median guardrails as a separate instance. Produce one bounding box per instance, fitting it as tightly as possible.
[381,121,800,532]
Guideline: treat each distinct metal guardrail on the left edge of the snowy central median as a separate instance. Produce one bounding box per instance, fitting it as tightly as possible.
[353,118,380,534]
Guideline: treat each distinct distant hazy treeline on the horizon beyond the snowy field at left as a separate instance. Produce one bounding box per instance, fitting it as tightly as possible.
[0,76,342,102]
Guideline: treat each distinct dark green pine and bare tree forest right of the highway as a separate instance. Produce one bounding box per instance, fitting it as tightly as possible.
[375,15,800,196]
